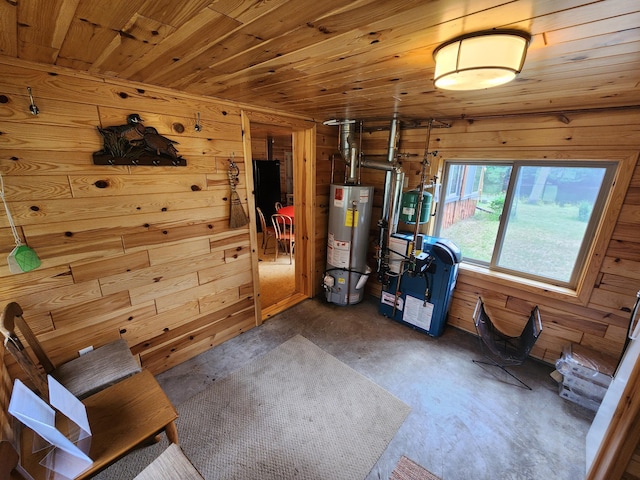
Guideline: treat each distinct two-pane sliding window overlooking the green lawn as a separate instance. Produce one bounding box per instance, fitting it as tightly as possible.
[436,161,616,288]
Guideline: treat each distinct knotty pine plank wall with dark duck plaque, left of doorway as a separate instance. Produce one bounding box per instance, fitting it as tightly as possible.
[0,59,312,375]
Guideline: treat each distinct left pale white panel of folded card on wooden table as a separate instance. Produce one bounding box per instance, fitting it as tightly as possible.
[8,379,93,478]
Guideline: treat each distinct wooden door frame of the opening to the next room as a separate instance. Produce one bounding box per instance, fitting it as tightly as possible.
[241,110,316,324]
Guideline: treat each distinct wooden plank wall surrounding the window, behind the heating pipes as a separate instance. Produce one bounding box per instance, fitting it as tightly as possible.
[363,111,640,363]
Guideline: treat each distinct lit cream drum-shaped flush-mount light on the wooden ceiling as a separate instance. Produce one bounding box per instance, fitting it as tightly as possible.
[433,30,531,90]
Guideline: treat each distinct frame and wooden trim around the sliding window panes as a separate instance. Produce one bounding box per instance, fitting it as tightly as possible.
[433,155,624,292]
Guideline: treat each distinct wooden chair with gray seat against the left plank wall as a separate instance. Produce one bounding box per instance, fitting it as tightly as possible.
[0,302,141,401]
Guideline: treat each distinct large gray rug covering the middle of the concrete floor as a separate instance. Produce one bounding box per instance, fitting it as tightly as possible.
[96,336,410,480]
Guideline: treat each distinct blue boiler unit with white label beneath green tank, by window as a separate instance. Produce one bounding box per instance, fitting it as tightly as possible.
[379,233,462,337]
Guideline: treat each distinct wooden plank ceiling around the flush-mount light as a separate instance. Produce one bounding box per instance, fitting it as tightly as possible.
[0,0,640,121]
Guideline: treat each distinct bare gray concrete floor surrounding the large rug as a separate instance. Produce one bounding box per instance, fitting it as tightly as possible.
[158,298,594,480]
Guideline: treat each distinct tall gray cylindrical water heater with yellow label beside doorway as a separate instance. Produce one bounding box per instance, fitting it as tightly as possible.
[323,184,373,305]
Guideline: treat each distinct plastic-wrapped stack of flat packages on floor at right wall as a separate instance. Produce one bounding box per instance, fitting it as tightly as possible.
[556,344,617,411]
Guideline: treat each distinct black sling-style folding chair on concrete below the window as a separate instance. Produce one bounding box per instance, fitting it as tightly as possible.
[473,297,542,390]
